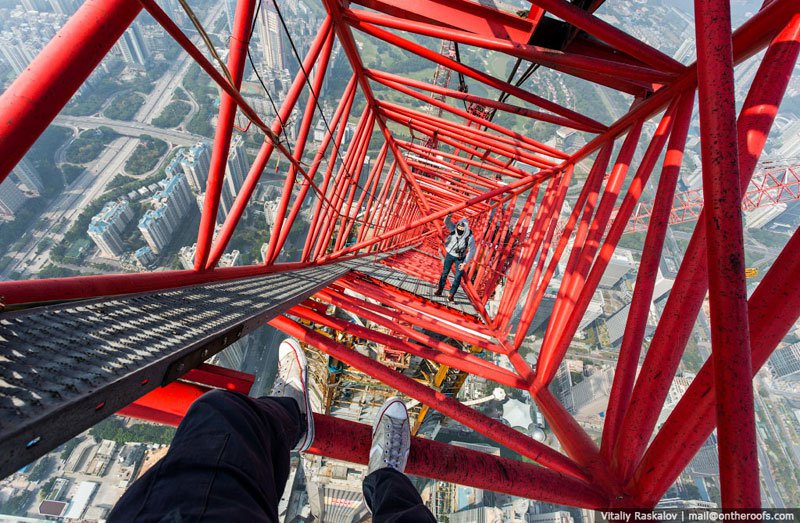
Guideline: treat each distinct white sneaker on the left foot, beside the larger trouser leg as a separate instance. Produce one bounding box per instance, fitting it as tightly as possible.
[270,338,314,452]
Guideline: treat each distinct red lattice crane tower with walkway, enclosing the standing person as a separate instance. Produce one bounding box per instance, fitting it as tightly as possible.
[0,0,800,509]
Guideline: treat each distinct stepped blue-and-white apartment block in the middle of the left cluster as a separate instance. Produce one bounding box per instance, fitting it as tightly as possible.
[139,173,195,254]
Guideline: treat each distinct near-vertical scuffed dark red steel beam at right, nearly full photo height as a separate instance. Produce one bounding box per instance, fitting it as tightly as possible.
[695,0,761,508]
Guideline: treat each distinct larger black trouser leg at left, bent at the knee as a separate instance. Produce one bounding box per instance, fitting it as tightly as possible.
[108,390,305,523]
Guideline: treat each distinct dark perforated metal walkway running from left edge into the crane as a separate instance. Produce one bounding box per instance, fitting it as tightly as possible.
[0,258,377,477]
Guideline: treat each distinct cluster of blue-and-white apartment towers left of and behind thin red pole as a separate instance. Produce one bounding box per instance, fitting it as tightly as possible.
[88,137,247,268]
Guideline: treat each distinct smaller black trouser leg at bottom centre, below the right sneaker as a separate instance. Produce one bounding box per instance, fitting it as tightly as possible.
[363,468,436,523]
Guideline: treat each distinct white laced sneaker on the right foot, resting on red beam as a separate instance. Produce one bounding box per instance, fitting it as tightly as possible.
[367,397,411,474]
